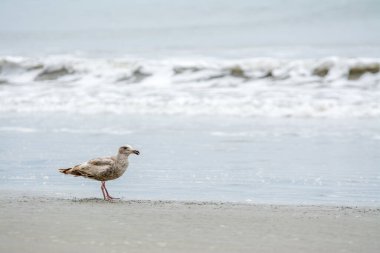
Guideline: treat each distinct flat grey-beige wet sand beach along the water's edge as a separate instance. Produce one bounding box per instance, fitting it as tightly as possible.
[0,192,380,253]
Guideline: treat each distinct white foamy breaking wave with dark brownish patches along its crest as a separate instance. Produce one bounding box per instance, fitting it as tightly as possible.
[0,56,380,117]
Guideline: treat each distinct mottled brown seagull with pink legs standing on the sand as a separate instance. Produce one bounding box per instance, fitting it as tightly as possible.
[59,145,140,201]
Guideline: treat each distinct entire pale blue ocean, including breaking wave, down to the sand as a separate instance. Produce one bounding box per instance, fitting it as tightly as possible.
[0,0,380,206]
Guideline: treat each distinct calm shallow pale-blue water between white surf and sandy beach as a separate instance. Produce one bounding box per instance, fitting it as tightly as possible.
[0,113,380,206]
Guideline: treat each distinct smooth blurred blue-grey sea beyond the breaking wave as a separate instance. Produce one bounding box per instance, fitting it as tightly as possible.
[0,0,380,58]
